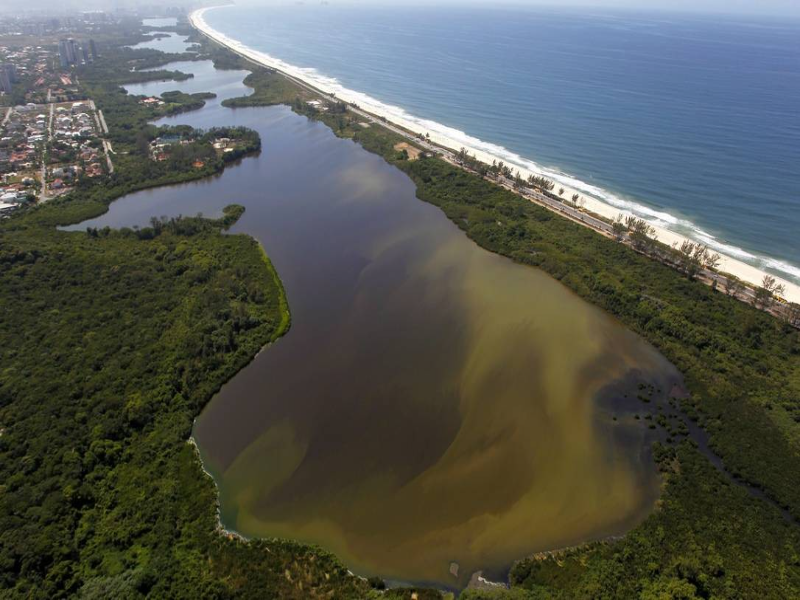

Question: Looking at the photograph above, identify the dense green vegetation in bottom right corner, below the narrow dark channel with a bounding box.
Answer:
[511,443,800,600]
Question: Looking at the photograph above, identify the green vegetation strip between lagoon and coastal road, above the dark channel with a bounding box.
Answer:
[382,152,800,508]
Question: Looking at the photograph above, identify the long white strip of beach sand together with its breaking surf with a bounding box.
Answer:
[189,5,800,303]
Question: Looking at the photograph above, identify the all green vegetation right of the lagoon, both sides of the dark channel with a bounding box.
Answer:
[203,37,800,599]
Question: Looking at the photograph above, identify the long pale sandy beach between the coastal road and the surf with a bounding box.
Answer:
[189,7,800,303]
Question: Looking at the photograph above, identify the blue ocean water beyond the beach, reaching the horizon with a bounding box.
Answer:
[205,4,800,282]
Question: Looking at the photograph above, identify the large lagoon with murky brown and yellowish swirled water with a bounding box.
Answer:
[70,54,678,587]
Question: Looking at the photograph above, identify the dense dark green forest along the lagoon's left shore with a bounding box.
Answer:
[0,24,372,599]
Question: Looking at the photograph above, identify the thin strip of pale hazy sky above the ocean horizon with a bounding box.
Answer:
[0,0,800,17]
